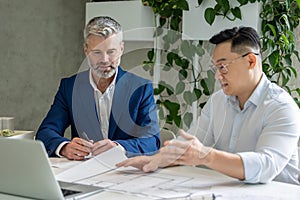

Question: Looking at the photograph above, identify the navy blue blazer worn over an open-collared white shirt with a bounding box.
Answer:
[36,67,160,157]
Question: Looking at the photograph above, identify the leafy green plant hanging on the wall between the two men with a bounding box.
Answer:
[142,0,214,127]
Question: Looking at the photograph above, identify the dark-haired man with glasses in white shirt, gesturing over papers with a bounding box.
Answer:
[118,27,300,184]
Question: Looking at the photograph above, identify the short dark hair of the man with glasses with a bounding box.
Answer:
[209,26,261,54]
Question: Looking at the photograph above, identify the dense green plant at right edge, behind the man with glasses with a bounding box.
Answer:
[260,0,300,107]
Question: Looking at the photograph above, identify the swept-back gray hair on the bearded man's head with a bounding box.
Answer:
[83,16,123,44]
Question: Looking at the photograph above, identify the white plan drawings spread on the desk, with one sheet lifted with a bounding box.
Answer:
[56,148,232,199]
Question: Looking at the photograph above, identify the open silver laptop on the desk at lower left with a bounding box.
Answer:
[0,138,103,200]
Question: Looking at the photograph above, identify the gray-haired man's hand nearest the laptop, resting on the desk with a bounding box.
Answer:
[60,137,93,160]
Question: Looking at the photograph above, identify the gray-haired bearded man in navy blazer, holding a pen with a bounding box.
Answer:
[36,16,160,160]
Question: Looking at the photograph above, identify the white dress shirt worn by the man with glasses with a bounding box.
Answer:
[197,74,300,184]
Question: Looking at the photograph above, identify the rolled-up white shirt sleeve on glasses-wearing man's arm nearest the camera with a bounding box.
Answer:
[238,99,300,183]
